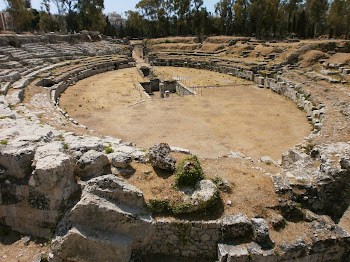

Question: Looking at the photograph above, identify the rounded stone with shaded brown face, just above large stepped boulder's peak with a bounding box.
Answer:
[77,150,109,178]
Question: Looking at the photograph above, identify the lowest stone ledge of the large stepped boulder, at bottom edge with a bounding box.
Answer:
[51,225,133,262]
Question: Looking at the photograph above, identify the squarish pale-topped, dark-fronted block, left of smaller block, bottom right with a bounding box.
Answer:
[222,213,253,241]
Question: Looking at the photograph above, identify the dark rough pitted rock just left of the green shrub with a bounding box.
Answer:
[148,143,176,171]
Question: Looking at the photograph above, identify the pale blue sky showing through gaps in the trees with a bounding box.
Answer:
[0,0,219,14]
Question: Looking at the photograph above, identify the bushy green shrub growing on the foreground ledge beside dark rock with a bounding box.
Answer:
[175,156,204,187]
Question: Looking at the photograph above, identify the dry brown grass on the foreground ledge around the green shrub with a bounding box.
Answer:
[119,154,278,219]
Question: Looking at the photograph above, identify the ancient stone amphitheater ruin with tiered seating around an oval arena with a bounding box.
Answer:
[0,34,350,262]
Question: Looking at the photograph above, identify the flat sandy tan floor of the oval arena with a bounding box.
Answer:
[60,67,311,160]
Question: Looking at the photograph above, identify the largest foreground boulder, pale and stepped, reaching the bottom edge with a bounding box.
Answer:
[51,175,155,262]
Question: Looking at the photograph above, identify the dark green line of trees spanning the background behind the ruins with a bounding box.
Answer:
[5,0,350,38]
